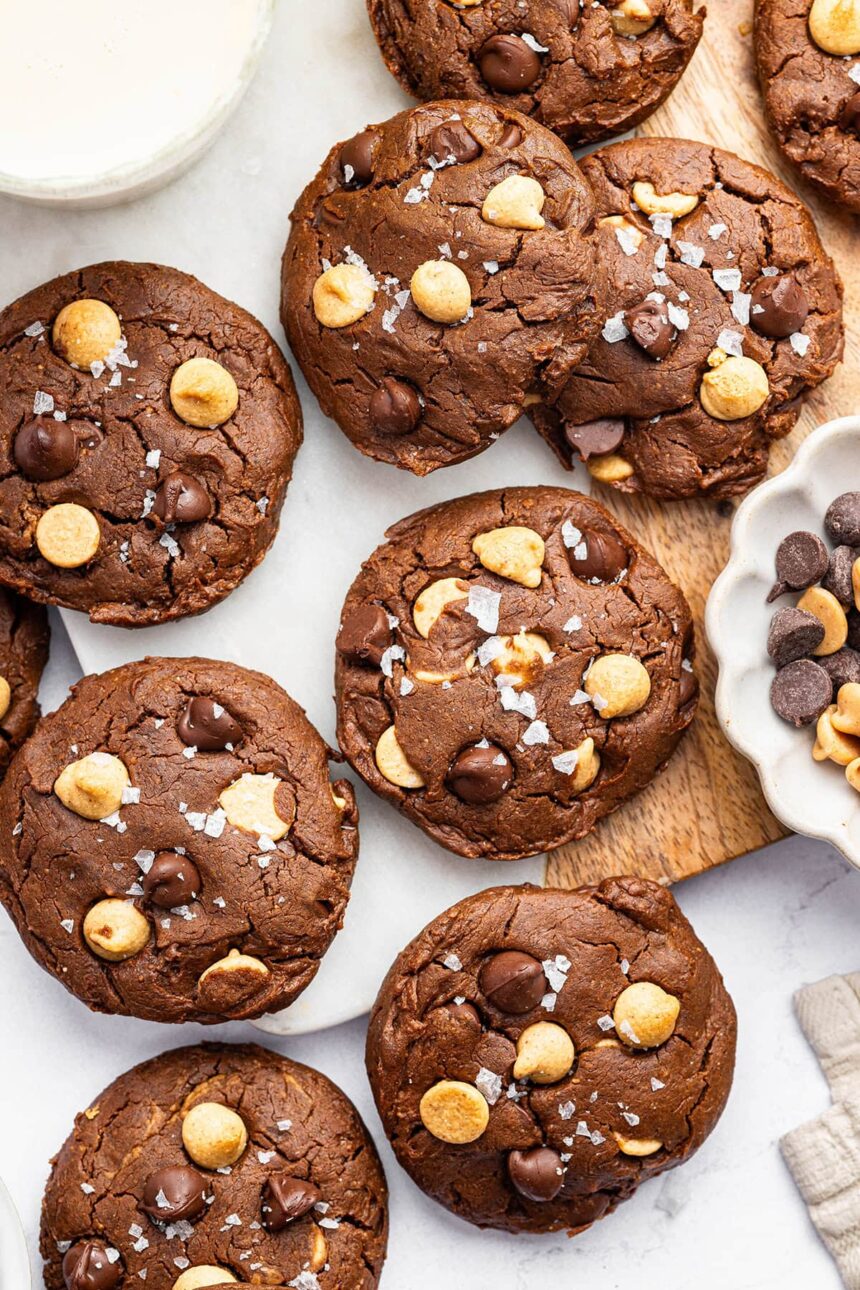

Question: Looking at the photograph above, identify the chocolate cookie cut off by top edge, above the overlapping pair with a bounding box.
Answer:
[367,0,704,146]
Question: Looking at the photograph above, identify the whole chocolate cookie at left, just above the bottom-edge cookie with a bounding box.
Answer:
[0,658,358,1023]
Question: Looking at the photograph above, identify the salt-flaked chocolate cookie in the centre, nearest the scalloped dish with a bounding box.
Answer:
[337,488,698,860]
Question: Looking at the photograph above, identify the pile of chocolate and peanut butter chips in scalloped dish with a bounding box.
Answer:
[767,493,860,792]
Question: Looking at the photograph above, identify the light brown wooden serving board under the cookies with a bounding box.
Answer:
[547,0,860,886]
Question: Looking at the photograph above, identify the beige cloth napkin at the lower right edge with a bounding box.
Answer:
[780,973,860,1290]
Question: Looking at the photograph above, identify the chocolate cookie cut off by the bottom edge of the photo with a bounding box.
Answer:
[41,1044,388,1290]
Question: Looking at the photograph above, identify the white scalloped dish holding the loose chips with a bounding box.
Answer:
[705,417,860,868]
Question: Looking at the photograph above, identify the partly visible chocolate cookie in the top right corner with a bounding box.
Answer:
[756,0,860,212]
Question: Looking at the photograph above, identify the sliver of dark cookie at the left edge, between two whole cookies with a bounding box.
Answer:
[0,588,49,779]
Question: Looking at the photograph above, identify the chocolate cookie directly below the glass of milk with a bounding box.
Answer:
[0,263,302,627]
